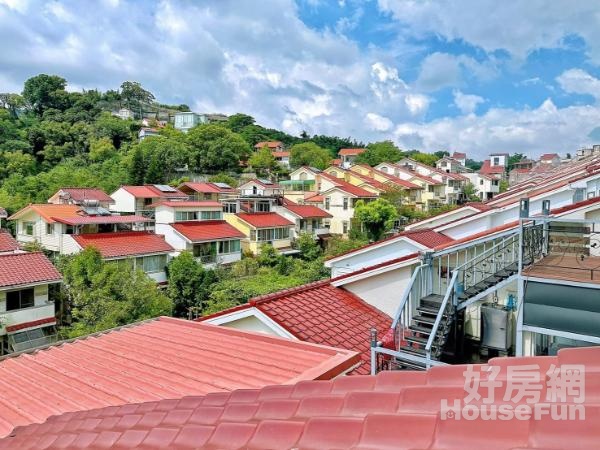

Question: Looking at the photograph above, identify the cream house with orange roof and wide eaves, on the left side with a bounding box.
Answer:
[9,203,151,255]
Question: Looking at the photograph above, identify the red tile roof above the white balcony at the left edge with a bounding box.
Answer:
[0,253,62,287]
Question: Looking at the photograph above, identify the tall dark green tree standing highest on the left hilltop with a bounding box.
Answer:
[23,74,67,117]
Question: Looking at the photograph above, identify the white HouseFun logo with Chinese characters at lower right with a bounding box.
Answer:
[441,364,585,420]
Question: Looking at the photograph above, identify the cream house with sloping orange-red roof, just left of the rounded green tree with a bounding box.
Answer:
[319,173,377,235]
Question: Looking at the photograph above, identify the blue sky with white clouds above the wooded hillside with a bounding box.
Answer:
[0,0,600,159]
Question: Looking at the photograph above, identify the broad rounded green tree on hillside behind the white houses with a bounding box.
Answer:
[187,124,251,172]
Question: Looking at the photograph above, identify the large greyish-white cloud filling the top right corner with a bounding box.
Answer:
[378,0,600,62]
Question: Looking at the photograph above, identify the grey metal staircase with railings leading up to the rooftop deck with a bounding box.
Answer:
[392,235,526,369]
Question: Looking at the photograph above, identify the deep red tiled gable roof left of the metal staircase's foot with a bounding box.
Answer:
[199,280,392,374]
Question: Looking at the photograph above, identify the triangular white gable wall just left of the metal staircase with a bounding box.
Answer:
[343,266,416,316]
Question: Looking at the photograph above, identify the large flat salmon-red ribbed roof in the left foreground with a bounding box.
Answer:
[0,317,359,438]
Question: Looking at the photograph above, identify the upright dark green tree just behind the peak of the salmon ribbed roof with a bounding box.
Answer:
[167,252,206,317]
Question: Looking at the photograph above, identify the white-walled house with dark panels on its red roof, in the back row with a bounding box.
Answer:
[110,184,188,219]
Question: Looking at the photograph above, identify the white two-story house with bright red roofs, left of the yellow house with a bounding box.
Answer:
[155,200,246,266]
